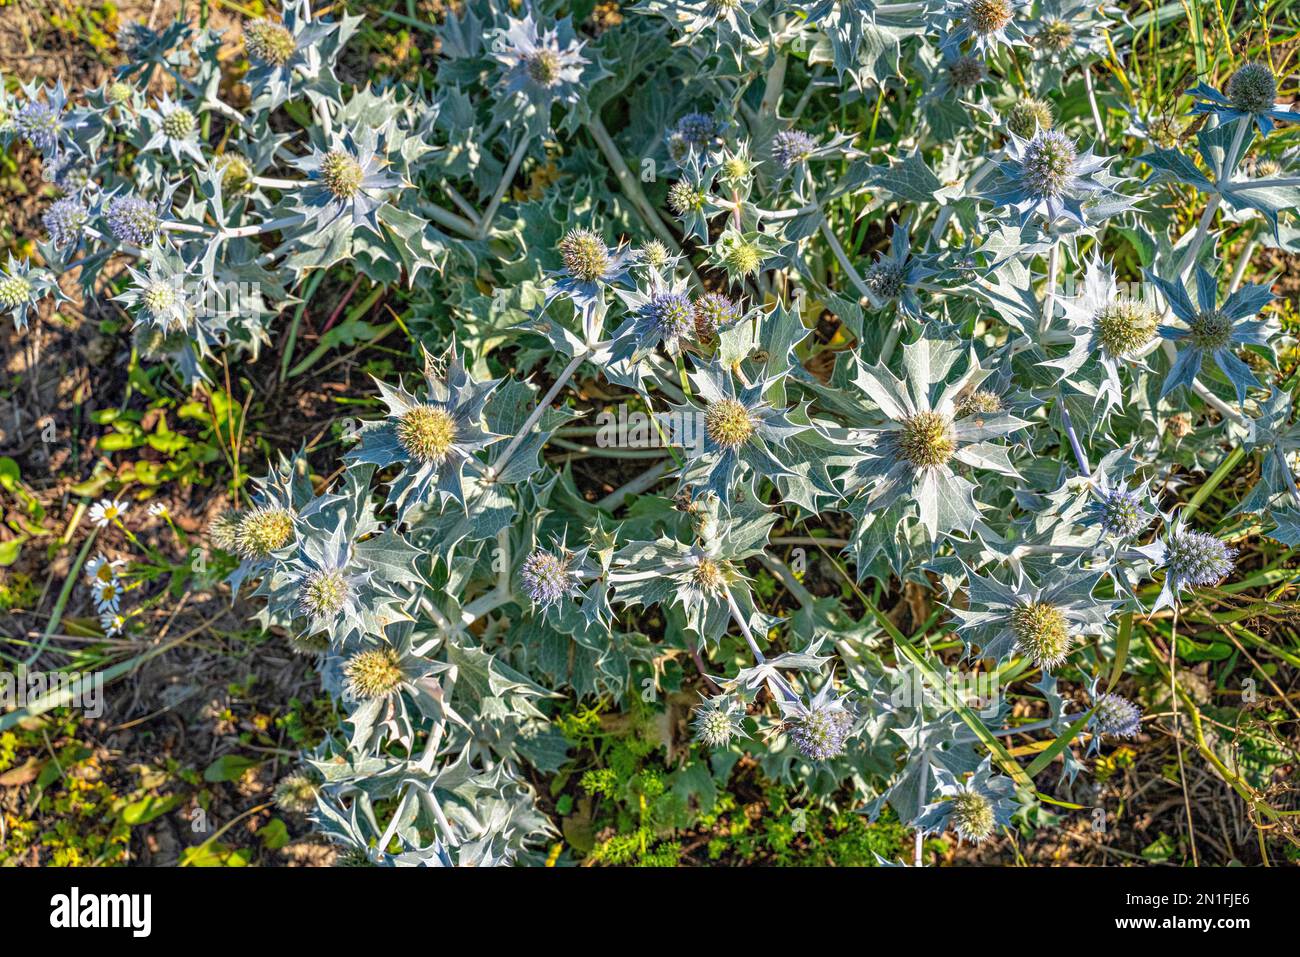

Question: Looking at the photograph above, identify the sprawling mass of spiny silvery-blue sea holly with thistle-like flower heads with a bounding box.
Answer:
[15,0,1300,866]
